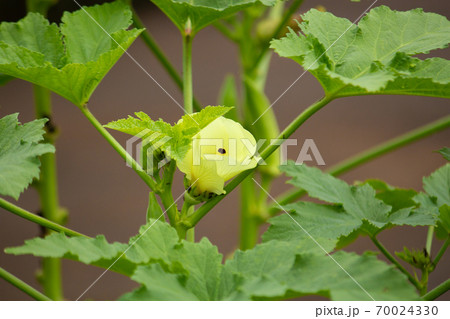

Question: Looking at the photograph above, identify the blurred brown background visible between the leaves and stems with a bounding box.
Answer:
[0,0,450,300]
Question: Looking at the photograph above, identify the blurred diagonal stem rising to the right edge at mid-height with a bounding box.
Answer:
[270,116,450,210]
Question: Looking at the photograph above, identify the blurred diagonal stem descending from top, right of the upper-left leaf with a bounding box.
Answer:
[133,10,202,111]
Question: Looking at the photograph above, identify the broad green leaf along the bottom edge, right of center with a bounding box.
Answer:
[224,244,418,300]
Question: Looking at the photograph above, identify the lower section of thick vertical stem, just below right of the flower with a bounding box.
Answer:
[240,174,259,250]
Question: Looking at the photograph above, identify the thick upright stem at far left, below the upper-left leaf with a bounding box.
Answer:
[33,85,67,300]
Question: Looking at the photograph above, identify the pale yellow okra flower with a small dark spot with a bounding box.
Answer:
[177,117,257,195]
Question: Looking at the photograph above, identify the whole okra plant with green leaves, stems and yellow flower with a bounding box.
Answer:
[0,0,450,300]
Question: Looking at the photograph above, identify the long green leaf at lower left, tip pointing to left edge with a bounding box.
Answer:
[5,220,178,276]
